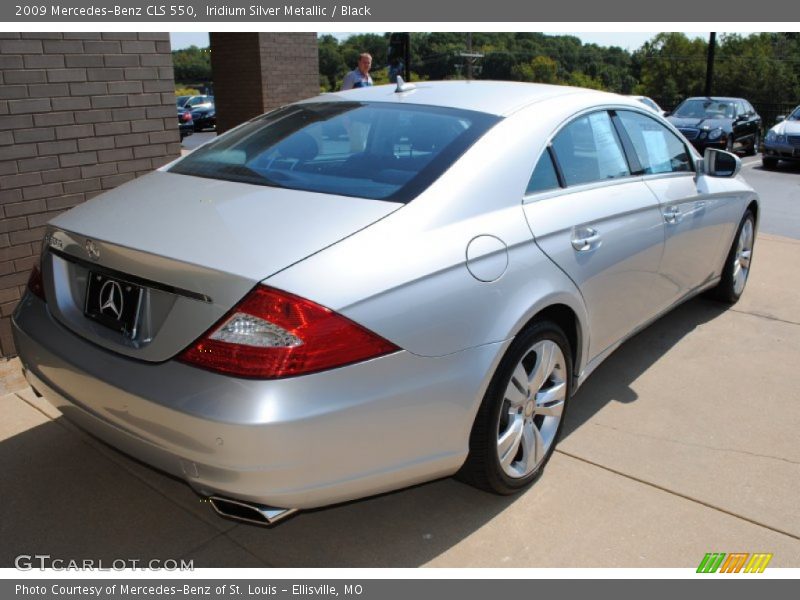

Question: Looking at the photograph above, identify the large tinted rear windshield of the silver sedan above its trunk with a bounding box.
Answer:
[170,102,499,202]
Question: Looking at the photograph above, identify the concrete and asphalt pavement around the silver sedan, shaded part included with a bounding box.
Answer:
[0,159,800,567]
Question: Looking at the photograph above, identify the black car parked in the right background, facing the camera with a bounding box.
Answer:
[669,97,761,156]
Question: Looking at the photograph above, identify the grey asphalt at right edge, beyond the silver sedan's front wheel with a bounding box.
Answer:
[742,155,800,239]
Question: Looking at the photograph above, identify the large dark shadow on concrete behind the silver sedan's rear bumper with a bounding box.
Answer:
[0,404,517,568]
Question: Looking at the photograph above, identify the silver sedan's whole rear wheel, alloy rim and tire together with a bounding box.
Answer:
[459,321,572,494]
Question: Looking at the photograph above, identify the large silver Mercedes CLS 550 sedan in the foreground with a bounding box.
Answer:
[13,81,759,523]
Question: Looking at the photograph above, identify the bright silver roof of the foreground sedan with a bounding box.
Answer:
[303,80,630,116]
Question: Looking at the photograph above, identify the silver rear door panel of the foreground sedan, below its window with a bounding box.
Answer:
[525,179,670,364]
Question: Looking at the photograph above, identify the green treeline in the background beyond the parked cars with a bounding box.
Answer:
[172,32,800,108]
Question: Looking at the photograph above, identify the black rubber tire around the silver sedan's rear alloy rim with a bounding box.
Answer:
[456,320,573,495]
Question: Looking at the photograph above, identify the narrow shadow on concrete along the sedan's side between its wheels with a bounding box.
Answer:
[562,296,728,438]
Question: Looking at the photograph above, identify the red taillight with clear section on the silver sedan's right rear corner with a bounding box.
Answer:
[179,285,400,379]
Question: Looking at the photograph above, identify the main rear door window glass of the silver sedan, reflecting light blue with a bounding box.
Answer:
[553,112,630,186]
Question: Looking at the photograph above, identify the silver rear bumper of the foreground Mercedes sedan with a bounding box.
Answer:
[12,294,506,508]
